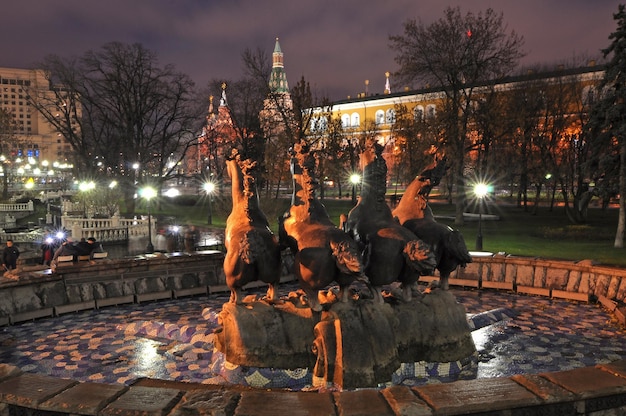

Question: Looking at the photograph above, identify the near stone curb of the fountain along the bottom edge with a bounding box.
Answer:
[0,360,626,416]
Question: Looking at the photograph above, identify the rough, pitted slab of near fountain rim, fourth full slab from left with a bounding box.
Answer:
[170,389,241,416]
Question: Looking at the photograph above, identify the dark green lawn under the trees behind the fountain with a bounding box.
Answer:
[90,192,626,266]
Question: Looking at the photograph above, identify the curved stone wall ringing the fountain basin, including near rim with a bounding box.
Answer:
[0,252,626,415]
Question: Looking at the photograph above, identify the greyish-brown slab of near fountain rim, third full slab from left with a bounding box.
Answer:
[99,386,183,416]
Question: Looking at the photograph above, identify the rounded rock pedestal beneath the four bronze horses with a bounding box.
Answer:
[216,290,476,388]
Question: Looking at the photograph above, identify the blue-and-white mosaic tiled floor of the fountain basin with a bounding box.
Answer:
[0,287,626,389]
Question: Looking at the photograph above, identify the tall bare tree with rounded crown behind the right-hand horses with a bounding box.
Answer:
[389,7,523,224]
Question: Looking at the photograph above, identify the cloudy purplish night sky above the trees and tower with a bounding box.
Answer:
[0,0,620,99]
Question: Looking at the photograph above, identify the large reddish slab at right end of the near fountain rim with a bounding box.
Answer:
[541,367,626,399]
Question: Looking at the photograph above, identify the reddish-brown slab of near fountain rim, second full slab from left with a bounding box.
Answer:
[39,383,127,415]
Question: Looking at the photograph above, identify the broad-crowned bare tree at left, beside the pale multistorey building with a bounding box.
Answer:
[29,42,202,213]
